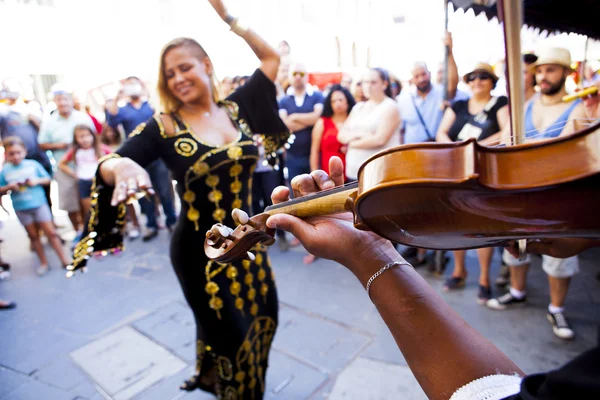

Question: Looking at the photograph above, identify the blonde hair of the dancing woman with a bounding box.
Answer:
[157,37,221,113]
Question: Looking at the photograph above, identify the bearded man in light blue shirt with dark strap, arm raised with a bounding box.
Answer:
[397,32,468,273]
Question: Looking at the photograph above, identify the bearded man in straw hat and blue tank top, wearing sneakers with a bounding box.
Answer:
[486,48,581,340]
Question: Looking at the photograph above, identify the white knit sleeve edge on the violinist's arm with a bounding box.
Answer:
[450,375,522,400]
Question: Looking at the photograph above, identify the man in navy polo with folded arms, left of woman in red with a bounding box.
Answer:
[279,63,323,181]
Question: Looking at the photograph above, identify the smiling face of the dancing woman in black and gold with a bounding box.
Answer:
[162,45,212,104]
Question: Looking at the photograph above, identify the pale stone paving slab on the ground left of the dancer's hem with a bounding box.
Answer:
[71,327,186,400]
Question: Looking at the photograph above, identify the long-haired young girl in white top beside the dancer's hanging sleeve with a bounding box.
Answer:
[58,125,111,219]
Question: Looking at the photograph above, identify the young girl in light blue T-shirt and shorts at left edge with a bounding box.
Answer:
[0,136,69,276]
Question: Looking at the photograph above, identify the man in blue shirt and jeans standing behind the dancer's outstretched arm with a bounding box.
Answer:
[106,76,177,241]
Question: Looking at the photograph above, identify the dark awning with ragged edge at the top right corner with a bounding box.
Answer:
[449,0,600,40]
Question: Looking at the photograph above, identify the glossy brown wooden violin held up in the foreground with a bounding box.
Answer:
[204,122,600,263]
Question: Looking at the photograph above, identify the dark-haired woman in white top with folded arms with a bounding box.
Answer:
[338,68,402,181]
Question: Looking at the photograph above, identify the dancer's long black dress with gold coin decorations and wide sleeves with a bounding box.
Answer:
[74,69,289,400]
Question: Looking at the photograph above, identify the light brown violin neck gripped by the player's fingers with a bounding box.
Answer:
[264,182,358,218]
